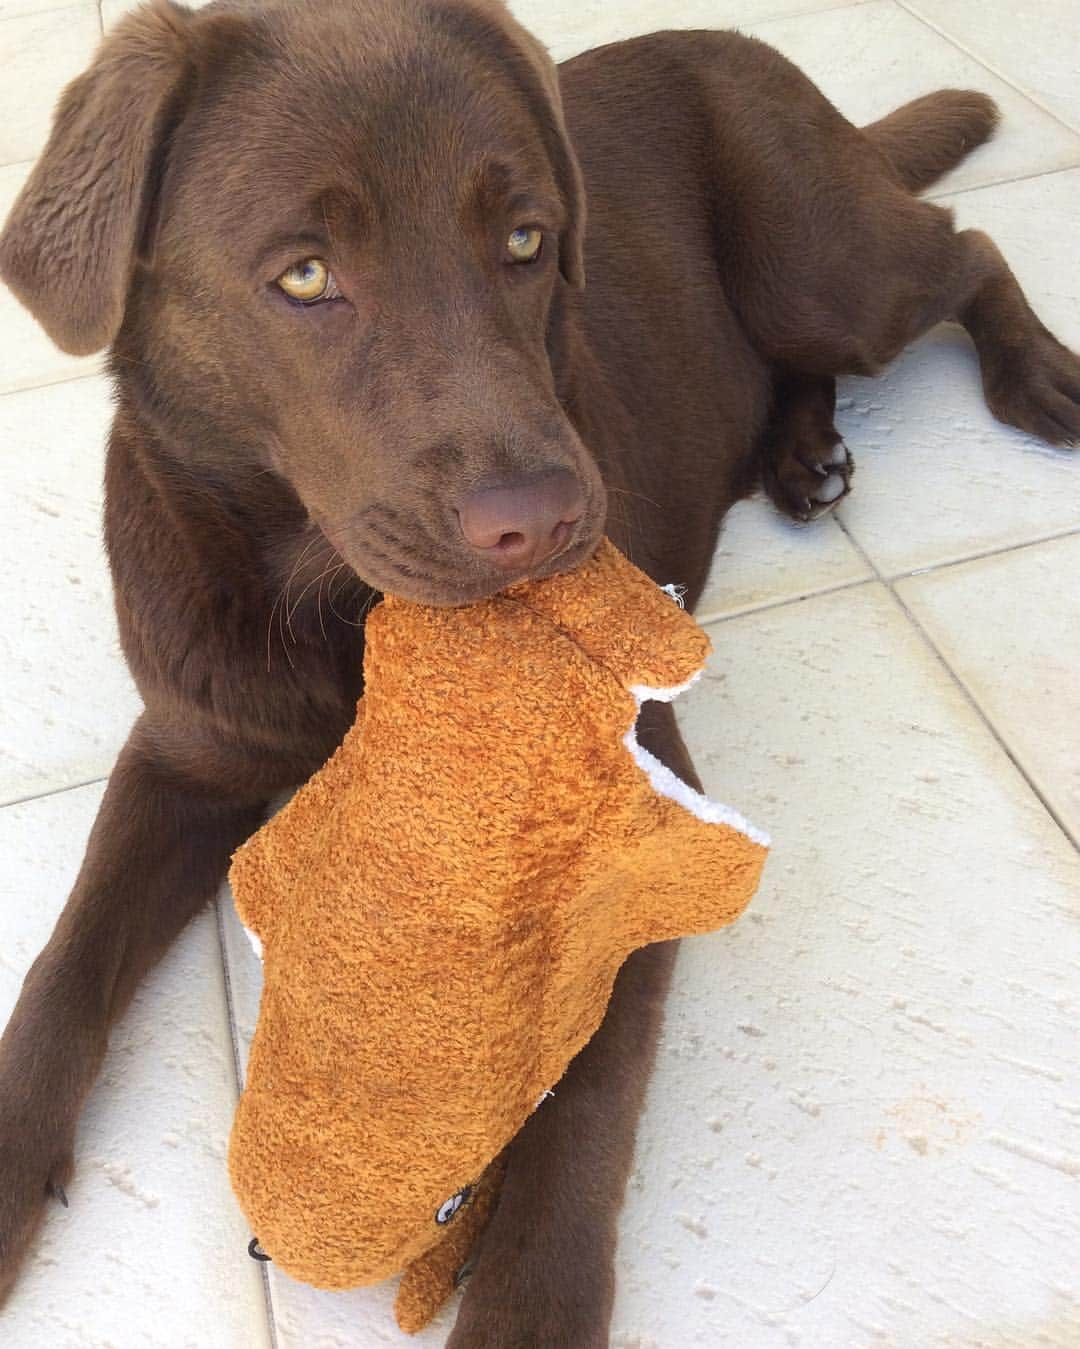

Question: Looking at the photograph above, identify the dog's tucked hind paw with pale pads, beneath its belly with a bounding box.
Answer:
[759,372,855,521]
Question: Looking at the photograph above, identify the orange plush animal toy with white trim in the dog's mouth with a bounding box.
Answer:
[229,542,767,1330]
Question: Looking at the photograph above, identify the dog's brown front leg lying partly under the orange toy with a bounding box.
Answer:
[448,703,700,1349]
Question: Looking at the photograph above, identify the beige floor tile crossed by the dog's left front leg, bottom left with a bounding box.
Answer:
[0,786,271,1349]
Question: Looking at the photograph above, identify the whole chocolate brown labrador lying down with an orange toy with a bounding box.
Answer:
[0,0,1080,1349]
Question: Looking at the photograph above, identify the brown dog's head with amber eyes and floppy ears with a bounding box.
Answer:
[0,0,605,603]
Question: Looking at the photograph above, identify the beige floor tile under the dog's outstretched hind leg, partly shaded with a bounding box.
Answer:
[837,170,1080,575]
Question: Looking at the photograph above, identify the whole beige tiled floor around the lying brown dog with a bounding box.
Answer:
[0,0,1080,1349]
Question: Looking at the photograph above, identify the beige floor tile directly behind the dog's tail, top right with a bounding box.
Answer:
[750,0,1080,192]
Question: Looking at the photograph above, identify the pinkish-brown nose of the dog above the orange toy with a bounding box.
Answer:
[458,468,585,571]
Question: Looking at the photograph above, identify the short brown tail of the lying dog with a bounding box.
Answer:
[863,89,1000,192]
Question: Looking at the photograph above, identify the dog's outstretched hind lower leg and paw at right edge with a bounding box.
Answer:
[948,229,1080,445]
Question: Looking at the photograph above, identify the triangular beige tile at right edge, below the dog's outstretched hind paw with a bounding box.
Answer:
[897,534,1080,842]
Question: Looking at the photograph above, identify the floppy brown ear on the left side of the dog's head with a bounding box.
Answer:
[0,0,193,356]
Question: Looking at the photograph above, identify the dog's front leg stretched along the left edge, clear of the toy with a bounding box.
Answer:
[0,716,264,1303]
